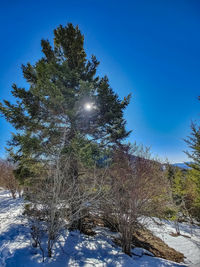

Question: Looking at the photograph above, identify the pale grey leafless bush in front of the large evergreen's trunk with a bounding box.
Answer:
[26,154,105,257]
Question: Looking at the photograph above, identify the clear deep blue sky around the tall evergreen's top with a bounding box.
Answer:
[0,0,200,162]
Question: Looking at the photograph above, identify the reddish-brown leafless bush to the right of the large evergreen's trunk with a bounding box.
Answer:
[103,146,168,255]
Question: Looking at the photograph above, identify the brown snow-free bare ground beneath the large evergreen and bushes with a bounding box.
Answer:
[81,215,184,263]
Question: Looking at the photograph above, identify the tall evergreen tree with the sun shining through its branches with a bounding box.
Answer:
[0,24,130,183]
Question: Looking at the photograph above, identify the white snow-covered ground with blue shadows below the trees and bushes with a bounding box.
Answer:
[0,190,200,267]
